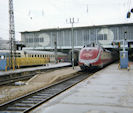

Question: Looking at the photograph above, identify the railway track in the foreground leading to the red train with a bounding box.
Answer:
[0,73,92,113]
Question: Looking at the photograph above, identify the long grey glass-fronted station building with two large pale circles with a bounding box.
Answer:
[21,23,133,50]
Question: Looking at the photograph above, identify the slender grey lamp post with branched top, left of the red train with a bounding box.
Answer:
[66,18,79,69]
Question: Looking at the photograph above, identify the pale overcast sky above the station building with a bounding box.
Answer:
[0,0,133,40]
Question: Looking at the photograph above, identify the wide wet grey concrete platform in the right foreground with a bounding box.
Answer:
[30,64,133,113]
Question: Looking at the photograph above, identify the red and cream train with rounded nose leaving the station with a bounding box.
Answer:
[79,44,118,70]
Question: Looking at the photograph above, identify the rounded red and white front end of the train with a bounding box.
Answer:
[79,47,101,70]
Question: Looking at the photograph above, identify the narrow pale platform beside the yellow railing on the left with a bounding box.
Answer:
[0,62,71,76]
